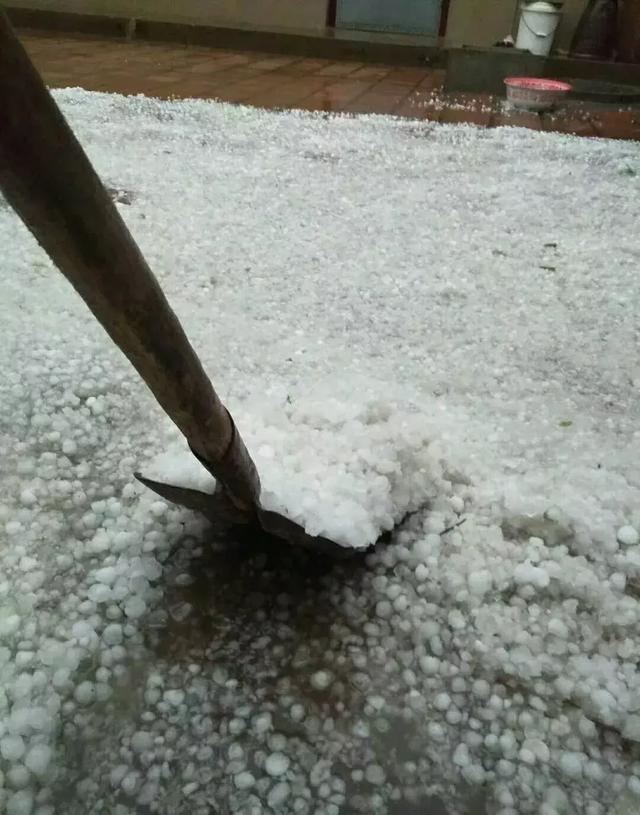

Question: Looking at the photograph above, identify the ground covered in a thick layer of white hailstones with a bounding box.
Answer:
[0,90,640,815]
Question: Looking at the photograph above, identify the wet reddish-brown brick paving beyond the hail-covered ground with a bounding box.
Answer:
[21,32,640,139]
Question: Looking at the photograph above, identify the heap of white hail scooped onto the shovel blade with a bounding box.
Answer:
[150,393,450,549]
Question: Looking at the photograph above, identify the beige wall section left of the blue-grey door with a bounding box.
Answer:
[8,0,328,30]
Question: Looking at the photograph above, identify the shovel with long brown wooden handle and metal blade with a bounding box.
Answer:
[0,9,352,556]
